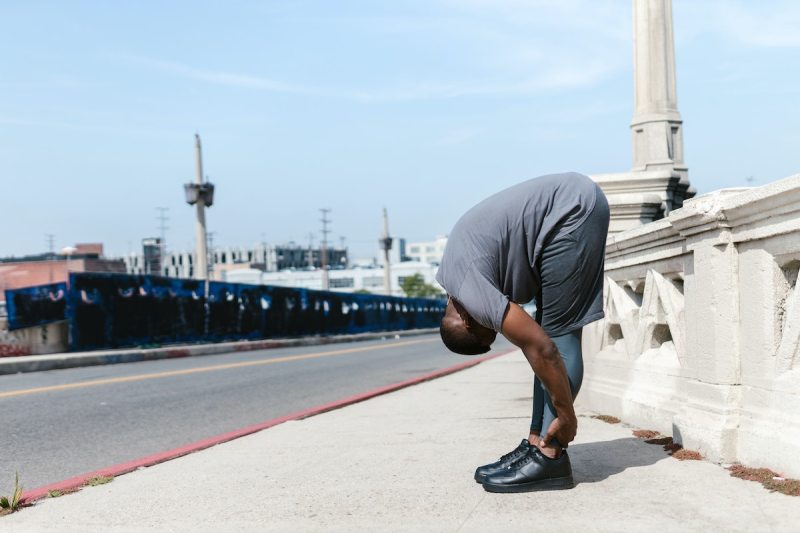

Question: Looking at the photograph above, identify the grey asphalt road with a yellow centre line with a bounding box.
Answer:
[0,335,510,494]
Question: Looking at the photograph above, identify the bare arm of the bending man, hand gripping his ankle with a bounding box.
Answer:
[502,302,578,447]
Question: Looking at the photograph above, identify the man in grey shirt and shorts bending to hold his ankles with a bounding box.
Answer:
[436,173,609,492]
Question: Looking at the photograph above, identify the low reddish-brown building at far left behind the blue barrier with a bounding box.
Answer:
[0,243,126,301]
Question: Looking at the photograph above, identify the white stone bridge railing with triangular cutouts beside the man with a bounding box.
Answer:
[579,175,800,477]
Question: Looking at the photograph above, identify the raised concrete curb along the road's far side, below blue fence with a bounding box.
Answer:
[0,328,438,375]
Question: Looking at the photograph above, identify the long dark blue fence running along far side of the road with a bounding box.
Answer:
[7,273,446,351]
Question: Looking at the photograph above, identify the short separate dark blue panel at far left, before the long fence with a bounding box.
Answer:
[5,283,67,330]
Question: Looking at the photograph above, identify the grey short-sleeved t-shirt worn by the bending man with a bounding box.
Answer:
[436,172,597,332]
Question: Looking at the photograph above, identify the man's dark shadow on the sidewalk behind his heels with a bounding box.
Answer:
[569,437,669,483]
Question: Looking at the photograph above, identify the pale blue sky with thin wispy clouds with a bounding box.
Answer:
[0,0,800,256]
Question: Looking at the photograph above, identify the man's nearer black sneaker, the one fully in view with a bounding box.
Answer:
[483,446,575,492]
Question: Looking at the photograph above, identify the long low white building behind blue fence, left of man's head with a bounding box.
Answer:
[222,261,444,296]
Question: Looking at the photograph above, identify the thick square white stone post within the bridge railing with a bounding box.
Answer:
[669,198,742,462]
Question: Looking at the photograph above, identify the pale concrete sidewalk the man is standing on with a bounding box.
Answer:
[0,352,800,533]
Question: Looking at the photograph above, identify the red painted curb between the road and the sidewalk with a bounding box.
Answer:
[21,348,516,504]
